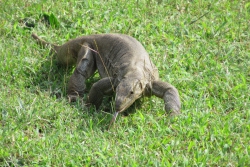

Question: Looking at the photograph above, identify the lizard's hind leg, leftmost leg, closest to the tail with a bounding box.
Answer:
[67,43,96,101]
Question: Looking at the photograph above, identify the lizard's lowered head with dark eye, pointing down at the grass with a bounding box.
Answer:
[115,79,145,112]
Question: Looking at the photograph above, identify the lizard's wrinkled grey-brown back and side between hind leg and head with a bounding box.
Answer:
[77,34,158,80]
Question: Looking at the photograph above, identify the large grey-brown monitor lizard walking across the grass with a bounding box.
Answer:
[32,33,181,128]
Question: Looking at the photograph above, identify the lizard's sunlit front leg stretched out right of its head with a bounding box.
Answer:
[147,81,181,115]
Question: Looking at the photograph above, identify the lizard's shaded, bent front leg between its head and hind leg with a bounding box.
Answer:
[87,77,115,109]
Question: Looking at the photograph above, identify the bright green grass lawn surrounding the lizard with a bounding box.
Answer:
[0,0,250,166]
